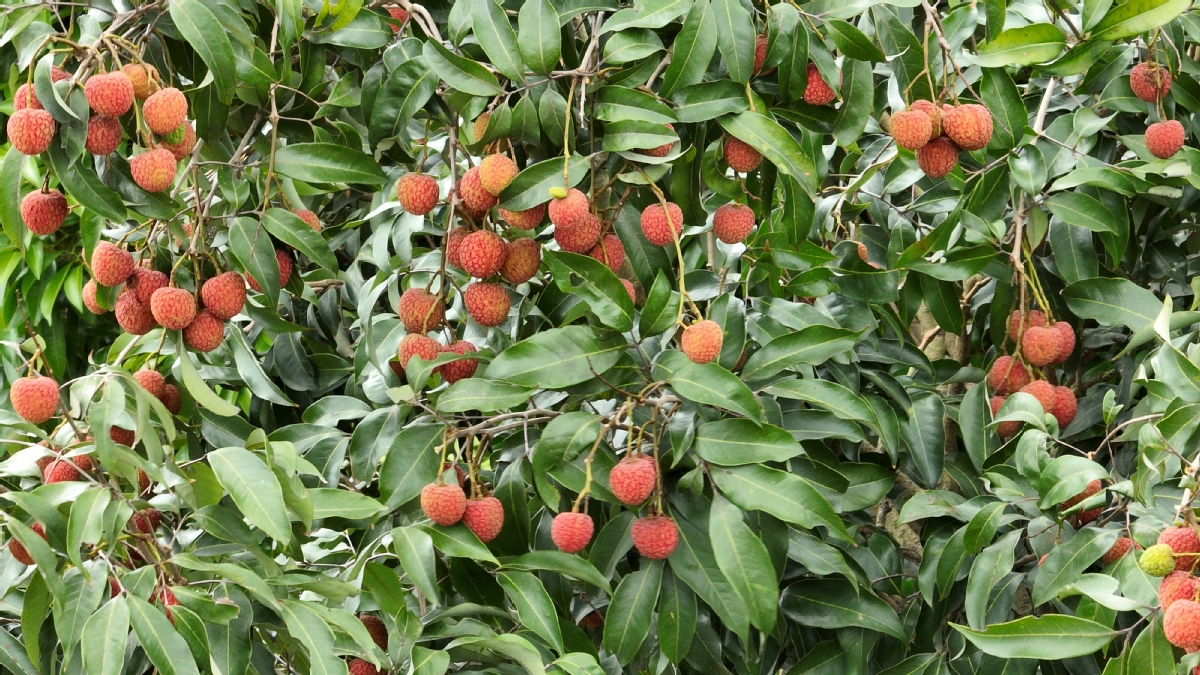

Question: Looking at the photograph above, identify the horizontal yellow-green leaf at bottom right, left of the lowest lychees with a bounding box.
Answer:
[950,614,1117,661]
